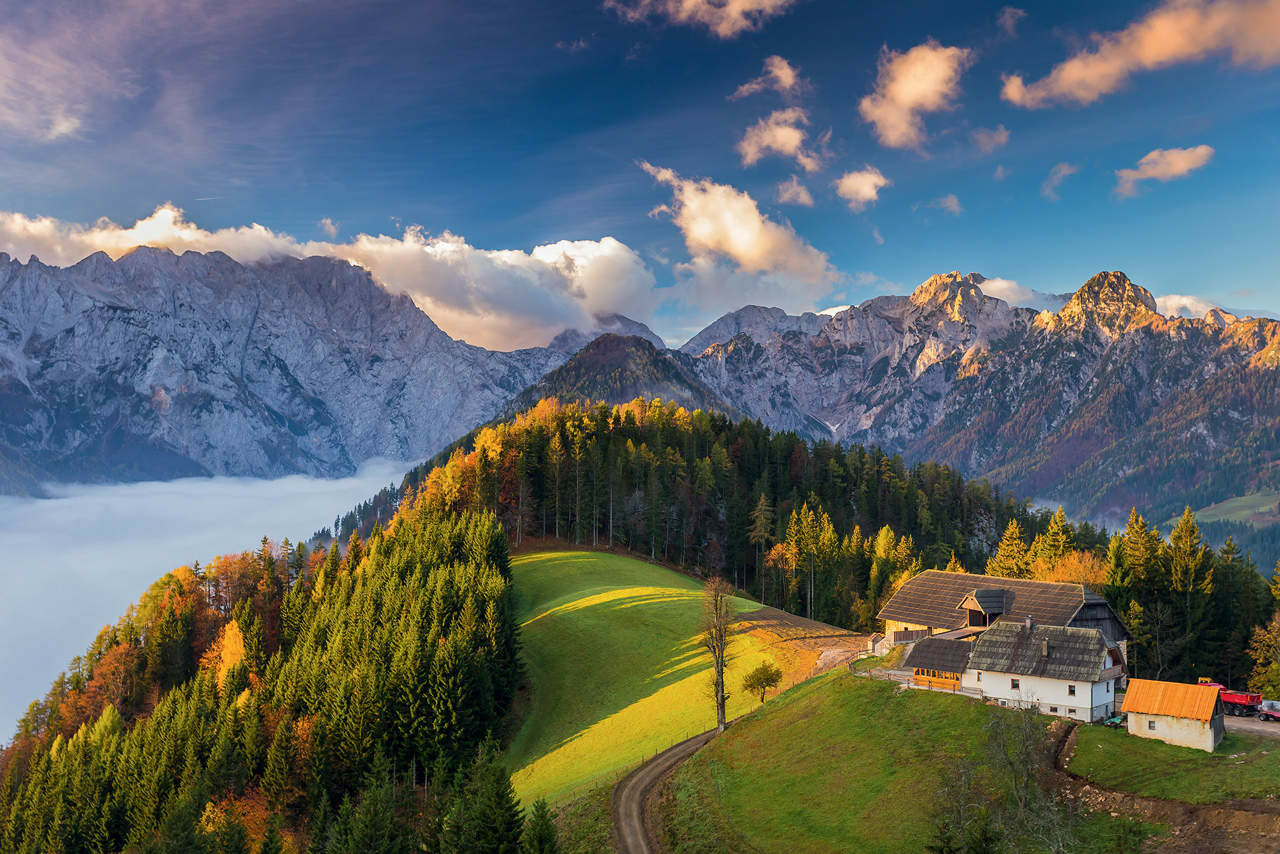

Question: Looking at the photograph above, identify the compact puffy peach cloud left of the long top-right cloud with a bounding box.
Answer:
[858,38,974,149]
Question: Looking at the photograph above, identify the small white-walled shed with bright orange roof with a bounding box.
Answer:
[1124,679,1225,753]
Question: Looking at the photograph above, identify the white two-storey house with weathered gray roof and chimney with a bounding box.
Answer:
[960,618,1124,722]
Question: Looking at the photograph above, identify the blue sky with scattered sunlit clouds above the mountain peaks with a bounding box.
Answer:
[0,0,1280,348]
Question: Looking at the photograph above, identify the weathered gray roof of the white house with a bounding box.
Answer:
[969,620,1107,682]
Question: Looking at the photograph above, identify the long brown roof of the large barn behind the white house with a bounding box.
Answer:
[877,570,1090,629]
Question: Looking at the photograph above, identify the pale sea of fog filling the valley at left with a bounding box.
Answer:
[0,461,410,744]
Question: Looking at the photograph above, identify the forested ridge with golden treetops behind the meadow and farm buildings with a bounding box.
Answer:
[399,401,1275,684]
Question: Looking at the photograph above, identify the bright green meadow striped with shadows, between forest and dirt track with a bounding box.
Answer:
[508,552,788,803]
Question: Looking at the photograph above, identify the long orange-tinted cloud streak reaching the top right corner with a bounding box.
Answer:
[1001,0,1280,109]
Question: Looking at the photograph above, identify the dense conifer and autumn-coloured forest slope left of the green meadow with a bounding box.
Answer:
[0,502,545,853]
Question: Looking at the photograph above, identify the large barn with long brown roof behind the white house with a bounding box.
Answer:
[877,570,1129,652]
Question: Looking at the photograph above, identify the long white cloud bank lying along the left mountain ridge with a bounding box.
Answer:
[0,205,657,350]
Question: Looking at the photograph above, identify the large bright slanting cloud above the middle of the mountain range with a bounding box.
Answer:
[641,163,837,287]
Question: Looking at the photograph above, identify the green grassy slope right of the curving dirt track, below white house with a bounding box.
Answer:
[664,671,1146,854]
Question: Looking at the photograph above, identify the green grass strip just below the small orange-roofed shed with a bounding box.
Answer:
[1071,726,1280,804]
